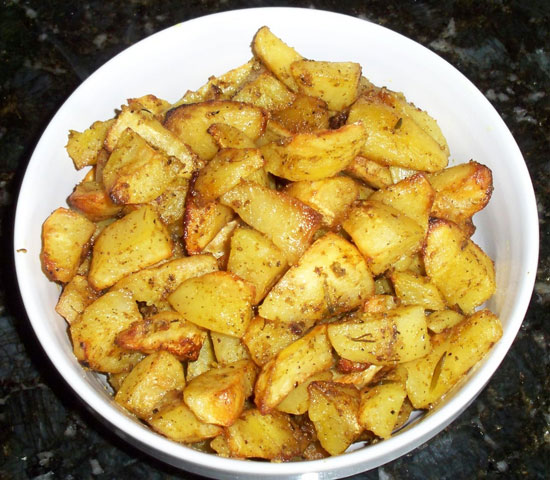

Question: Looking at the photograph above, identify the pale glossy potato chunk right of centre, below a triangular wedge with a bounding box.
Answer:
[342,200,424,275]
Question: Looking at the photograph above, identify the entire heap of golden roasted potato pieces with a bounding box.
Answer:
[41,27,502,462]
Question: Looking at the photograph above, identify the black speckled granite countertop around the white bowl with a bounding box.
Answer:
[0,0,550,480]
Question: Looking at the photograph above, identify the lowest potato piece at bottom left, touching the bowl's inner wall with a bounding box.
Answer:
[147,401,223,443]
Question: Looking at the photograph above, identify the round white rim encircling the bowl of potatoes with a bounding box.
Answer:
[14,7,539,478]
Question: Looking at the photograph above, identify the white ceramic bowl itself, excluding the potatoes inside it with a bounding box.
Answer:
[14,8,538,479]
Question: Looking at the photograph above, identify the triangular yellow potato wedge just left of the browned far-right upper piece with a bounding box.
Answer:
[369,173,435,232]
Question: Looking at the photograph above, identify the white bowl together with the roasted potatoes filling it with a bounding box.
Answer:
[14,8,538,478]
